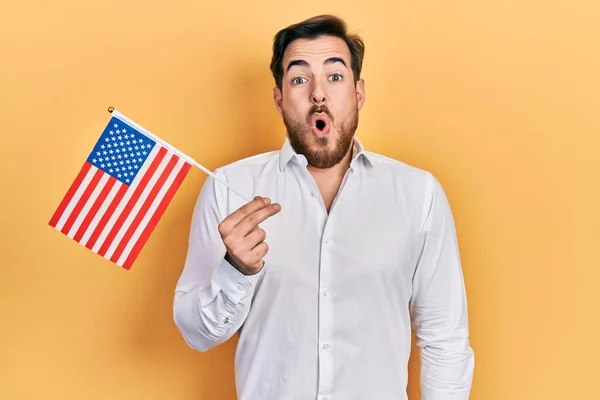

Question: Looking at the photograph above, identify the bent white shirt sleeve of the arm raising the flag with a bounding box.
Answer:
[173,171,262,351]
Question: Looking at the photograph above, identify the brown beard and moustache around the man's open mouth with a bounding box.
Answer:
[282,106,358,169]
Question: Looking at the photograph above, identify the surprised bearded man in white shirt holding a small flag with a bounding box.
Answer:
[174,16,474,400]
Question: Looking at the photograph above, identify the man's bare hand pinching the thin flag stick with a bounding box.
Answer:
[219,196,281,275]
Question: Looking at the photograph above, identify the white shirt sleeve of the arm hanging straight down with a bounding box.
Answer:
[410,175,474,400]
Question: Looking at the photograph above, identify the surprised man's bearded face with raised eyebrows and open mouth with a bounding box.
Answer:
[274,36,365,168]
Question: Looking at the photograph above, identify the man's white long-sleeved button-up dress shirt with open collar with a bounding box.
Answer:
[174,139,474,400]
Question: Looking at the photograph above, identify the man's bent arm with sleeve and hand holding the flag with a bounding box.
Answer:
[173,172,274,351]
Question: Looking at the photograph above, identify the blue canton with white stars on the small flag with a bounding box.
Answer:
[87,117,156,185]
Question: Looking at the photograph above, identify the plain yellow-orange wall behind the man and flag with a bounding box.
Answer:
[0,0,600,400]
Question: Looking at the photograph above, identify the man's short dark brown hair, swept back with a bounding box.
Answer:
[271,15,365,90]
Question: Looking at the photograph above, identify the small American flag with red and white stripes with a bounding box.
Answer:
[49,110,191,270]
